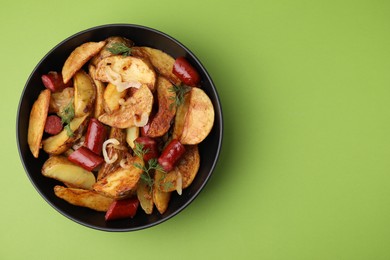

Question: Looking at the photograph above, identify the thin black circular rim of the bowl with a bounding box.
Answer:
[16,23,224,232]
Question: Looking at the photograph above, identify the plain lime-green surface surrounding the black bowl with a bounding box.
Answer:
[0,0,390,260]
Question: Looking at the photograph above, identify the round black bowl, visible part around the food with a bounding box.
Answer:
[16,24,223,231]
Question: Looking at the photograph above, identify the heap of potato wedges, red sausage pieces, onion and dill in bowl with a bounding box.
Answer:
[27,36,215,221]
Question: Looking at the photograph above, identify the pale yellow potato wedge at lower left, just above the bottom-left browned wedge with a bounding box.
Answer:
[42,156,96,190]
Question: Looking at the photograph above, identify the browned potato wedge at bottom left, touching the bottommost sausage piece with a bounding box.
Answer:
[54,185,114,212]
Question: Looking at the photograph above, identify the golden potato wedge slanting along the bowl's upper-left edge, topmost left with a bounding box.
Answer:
[62,41,106,84]
